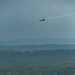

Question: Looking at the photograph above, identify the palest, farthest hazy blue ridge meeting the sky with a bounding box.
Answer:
[0,38,75,46]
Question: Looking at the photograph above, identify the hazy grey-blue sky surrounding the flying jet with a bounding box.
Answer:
[0,0,75,41]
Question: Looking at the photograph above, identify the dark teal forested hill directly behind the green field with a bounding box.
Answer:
[0,50,75,64]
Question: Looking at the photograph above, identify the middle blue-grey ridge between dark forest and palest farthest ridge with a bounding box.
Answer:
[0,44,75,51]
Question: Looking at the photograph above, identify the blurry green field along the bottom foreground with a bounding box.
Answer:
[0,63,75,75]
